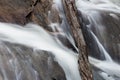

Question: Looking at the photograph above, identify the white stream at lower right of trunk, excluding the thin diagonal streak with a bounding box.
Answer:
[89,57,120,80]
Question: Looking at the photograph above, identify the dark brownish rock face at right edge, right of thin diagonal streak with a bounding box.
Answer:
[101,14,120,62]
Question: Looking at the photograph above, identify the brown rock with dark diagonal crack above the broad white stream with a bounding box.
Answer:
[0,0,60,31]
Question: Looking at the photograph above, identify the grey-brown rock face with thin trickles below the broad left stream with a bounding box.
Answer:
[0,42,66,80]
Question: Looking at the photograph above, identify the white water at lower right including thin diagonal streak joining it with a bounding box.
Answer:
[89,32,120,80]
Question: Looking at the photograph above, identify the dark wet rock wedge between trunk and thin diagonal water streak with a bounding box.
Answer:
[83,22,105,60]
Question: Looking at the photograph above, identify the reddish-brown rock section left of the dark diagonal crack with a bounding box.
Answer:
[0,0,31,24]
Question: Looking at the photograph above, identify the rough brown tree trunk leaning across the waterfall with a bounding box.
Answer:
[62,0,93,80]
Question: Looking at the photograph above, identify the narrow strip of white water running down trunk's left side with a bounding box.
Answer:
[53,0,78,51]
